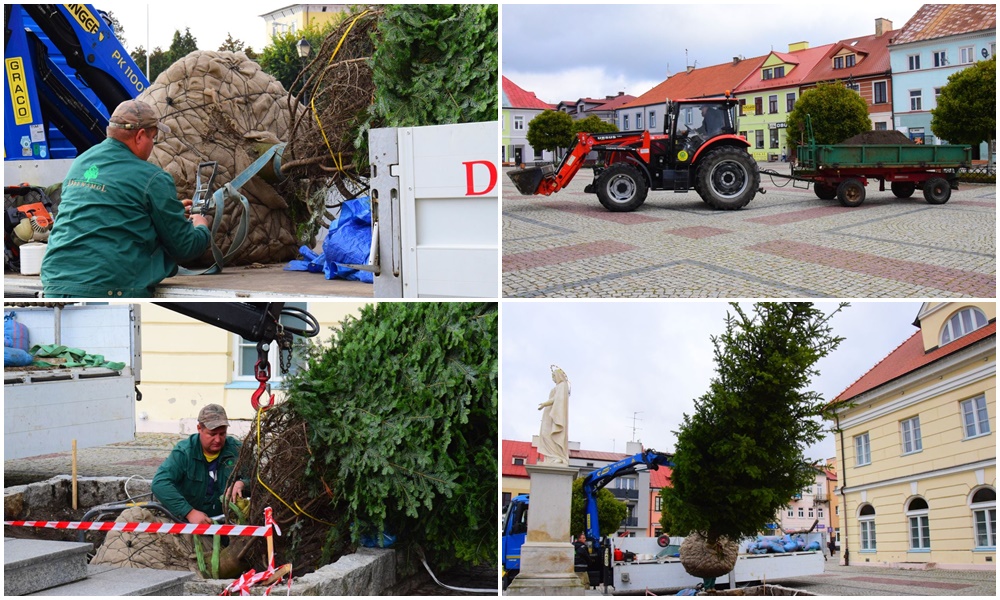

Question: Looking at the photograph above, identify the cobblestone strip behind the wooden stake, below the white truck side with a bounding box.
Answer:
[3,433,187,487]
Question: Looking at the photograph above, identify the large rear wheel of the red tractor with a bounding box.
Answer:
[695,146,760,210]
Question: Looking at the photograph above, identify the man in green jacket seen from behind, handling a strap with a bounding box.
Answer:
[41,100,211,298]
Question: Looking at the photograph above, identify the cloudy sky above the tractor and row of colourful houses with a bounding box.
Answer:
[501,0,923,104]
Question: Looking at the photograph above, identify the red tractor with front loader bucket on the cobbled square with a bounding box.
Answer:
[507,95,760,212]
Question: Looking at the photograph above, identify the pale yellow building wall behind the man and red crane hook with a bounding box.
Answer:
[136,302,365,435]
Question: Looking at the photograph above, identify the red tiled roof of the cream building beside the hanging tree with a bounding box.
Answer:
[834,321,997,403]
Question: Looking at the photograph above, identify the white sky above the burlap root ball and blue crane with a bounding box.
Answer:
[93,0,276,52]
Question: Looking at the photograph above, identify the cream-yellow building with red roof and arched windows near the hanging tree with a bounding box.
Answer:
[833,302,996,569]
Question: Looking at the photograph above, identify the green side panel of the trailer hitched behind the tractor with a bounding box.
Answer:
[798,144,972,170]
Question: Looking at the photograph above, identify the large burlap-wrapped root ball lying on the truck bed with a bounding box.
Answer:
[140,51,304,264]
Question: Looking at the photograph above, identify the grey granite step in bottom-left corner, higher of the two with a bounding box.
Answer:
[3,538,94,596]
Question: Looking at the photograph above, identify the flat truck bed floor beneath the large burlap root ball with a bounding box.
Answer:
[3,264,374,298]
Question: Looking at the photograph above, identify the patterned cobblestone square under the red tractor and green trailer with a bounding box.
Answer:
[502,163,996,298]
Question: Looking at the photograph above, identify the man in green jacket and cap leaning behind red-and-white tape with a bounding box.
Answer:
[152,404,245,524]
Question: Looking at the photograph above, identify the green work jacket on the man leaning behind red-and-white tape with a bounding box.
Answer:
[153,433,243,519]
